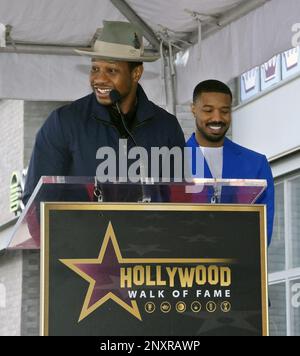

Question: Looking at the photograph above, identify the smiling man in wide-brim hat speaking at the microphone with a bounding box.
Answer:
[24,21,185,202]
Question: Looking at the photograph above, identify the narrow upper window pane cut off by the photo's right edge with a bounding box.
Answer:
[288,177,300,268]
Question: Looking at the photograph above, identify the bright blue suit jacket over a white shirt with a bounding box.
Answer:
[187,134,274,244]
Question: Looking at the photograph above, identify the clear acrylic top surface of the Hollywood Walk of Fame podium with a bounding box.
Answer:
[6,176,267,249]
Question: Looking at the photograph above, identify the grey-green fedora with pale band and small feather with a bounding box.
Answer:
[75,21,160,62]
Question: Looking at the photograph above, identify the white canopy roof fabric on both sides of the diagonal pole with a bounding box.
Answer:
[0,0,244,45]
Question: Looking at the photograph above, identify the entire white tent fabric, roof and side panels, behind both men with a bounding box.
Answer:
[0,0,300,104]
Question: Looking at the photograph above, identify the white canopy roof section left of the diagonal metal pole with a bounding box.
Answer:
[0,0,125,45]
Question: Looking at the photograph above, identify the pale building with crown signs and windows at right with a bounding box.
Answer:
[232,47,300,335]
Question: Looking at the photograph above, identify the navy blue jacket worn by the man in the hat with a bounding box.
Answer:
[23,85,185,202]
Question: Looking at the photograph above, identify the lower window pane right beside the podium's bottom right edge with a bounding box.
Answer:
[269,283,287,336]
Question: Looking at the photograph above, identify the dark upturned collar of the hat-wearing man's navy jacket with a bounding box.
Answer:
[91,84,155,126]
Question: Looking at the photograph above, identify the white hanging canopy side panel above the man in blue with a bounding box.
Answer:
[177,0,300,103]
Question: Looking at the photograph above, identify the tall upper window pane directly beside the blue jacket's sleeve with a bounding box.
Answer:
[268,183,285,273]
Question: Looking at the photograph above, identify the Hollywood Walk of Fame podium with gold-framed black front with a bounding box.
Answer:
[8,177,268,336]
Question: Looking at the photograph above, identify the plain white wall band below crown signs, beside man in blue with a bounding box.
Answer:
[232,77,300,158]
